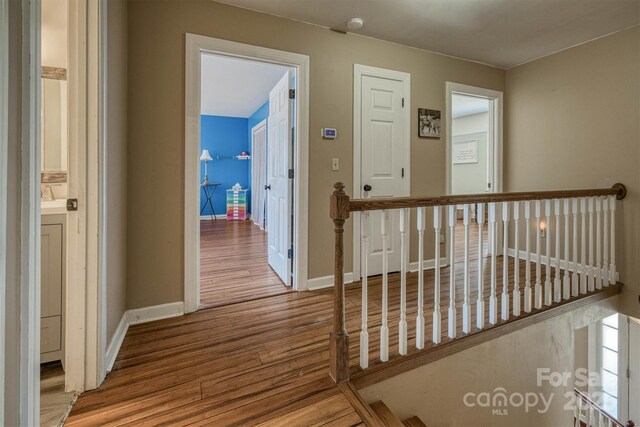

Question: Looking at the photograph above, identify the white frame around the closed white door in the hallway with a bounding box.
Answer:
[347,64,411,280]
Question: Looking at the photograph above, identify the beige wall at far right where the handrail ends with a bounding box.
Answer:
[504,27,640,317]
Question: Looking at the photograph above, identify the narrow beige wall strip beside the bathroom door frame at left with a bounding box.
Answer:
[106,0,127,343]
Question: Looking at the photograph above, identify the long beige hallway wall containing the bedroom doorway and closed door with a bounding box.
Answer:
[127,0,505,308]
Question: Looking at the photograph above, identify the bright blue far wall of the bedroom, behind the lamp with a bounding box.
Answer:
[200,115,251,215]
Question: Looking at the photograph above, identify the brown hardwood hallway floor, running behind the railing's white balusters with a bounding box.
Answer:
[67,221,608,426]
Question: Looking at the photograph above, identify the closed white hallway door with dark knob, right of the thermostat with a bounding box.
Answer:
[353,65,410,277]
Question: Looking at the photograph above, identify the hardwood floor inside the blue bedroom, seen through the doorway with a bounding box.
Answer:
[200,220,291,308]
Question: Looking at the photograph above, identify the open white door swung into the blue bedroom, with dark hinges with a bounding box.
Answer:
[267,71,292,285]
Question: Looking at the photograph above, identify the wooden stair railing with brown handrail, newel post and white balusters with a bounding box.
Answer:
[330,182,626,382]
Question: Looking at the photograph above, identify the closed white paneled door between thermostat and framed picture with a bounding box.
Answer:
[354,69,409,275]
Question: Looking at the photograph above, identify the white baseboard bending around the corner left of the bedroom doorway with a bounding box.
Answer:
[106,301,184,372]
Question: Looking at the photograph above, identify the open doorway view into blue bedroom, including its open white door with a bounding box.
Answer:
[199,53,296,307]
